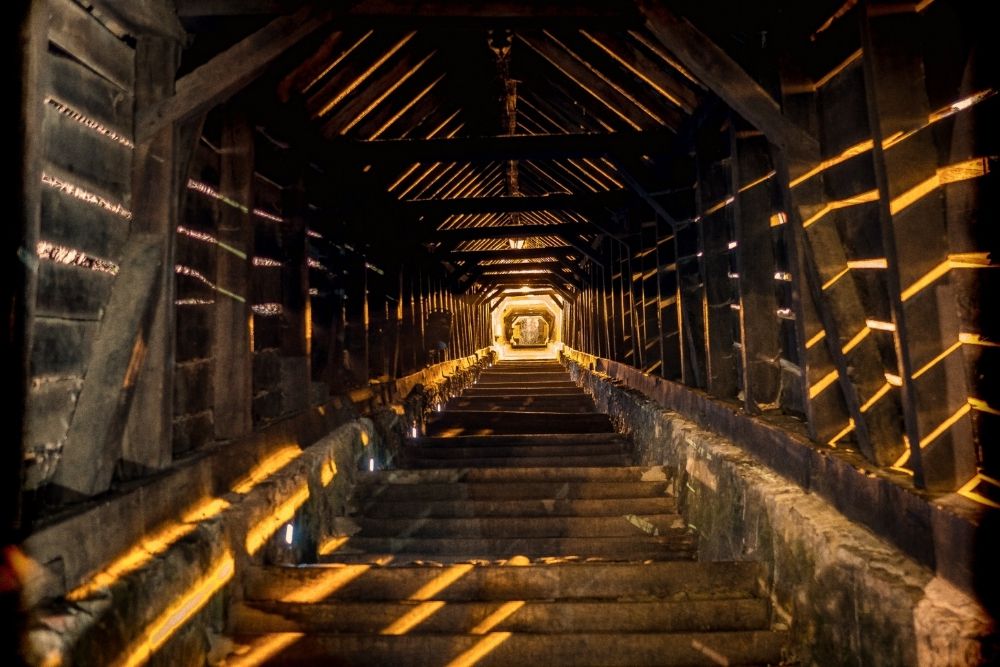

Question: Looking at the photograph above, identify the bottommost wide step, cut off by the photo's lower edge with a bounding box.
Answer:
[227,630,787,667]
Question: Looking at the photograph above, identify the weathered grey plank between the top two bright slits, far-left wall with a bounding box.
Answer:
[42,105,132,196]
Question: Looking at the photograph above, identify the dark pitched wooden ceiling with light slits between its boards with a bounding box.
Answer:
[177,0,840,298]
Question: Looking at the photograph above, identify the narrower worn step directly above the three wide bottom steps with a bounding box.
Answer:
[320,530,696,563]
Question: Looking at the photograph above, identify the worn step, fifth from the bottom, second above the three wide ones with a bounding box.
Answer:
[353,514,688,539]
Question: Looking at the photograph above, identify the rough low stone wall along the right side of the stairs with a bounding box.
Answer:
[563,351,995,667]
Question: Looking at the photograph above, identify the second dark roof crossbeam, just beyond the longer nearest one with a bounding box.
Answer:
[403,190,630,218]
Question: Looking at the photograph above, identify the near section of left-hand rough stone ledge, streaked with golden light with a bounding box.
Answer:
[25,419,377,664]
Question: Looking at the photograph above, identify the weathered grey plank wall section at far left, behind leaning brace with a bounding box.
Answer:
[25,0,135,490]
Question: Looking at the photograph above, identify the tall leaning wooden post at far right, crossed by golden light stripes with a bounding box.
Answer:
[862,2,976,491]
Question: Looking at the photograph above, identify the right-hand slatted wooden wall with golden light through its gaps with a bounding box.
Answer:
[567,0,1000,503]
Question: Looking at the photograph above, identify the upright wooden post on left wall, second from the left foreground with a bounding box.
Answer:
[212,103,254,439]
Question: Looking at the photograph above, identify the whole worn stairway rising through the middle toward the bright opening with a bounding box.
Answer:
[230,362,786,666]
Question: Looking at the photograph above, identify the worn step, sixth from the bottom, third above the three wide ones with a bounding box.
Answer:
[355,482,667,503]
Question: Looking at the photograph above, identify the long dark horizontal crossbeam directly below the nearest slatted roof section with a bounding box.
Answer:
[348,129,674,163]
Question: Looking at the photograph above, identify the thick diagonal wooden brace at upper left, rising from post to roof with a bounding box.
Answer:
[135,4,335,144]
